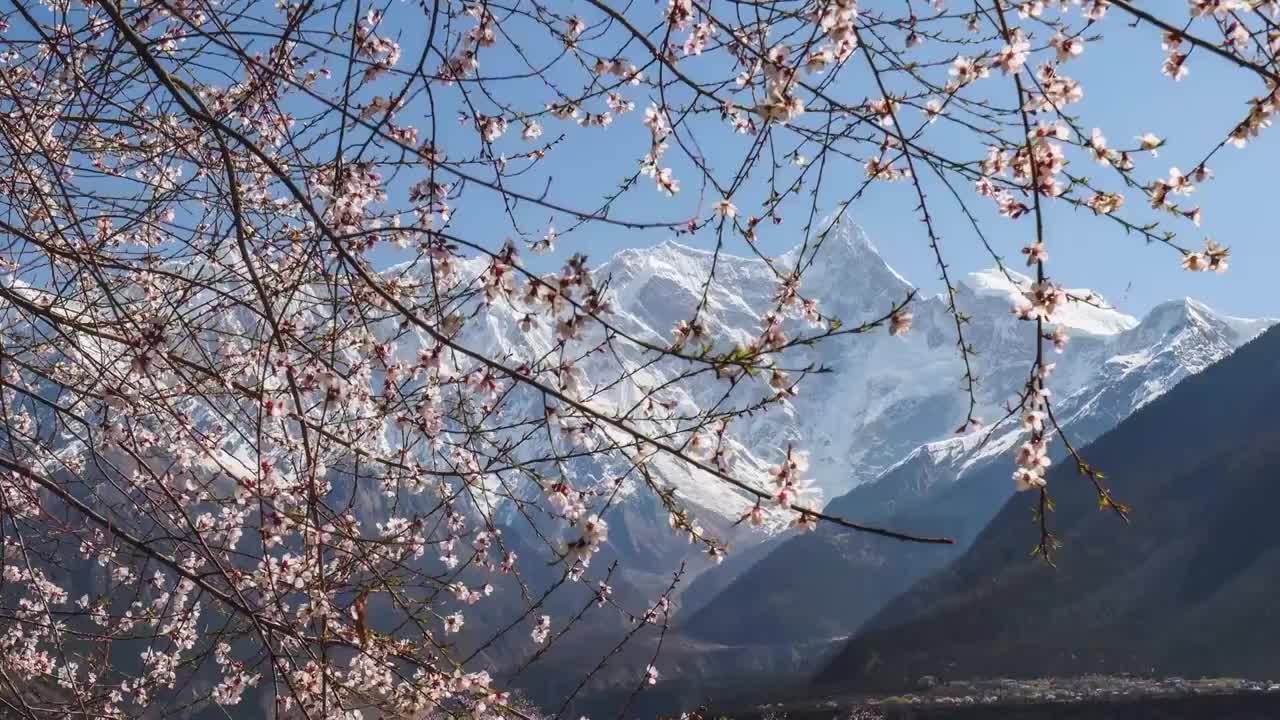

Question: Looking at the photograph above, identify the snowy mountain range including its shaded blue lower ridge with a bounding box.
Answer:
[486,215,1272,697]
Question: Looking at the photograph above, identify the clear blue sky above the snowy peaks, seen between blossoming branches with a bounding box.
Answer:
[363,0,1280,316]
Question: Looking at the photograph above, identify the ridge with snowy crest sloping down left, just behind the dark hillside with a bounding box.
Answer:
[685,254,1272,646]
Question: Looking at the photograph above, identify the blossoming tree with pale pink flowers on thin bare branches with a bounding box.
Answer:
[0,0,1280,719]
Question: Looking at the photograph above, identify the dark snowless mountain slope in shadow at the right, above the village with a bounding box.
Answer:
[818,331,1280,689]
